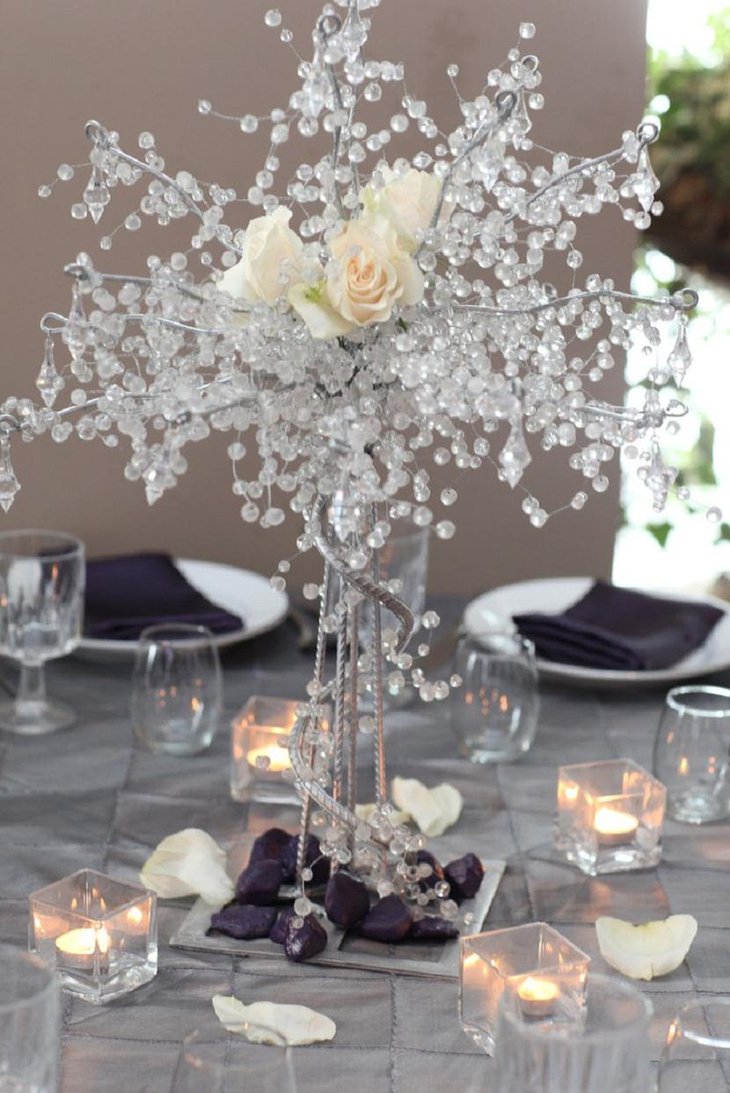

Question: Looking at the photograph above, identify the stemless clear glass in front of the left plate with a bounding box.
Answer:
[131,623,223,755]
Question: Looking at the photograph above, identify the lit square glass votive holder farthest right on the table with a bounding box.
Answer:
[555,759,667,877]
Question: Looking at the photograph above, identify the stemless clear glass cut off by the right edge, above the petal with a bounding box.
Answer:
[654,686,730,823]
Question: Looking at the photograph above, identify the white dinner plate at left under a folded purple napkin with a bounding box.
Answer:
[75,557,289,660]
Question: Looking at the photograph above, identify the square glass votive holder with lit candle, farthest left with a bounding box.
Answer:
[28,869,157,1006]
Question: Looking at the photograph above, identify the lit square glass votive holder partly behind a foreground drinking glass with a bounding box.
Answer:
[459,922,590,1055]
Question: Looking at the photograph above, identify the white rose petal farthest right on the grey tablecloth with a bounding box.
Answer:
[596,915,697,979]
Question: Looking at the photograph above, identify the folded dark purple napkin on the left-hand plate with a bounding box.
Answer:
[84,553,244,642]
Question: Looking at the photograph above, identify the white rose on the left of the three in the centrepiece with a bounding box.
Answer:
[217,205,304,304]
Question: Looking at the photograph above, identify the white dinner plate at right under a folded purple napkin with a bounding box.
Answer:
[463,577,730,686]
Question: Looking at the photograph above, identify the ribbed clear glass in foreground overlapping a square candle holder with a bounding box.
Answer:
[494,975,651,1093]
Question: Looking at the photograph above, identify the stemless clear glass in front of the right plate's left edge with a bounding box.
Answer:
[451,633,540,763]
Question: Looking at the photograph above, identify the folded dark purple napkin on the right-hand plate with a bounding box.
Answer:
[514,580,725,671]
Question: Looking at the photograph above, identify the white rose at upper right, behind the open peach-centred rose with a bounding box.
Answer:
[363,164,441,251]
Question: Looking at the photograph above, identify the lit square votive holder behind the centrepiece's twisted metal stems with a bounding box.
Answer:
[231,694,302,804]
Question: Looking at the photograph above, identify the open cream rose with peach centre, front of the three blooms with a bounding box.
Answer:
[325,216,423,327]
